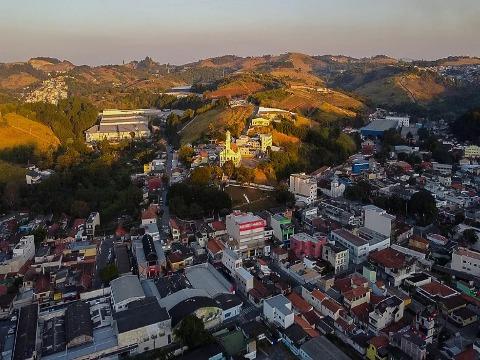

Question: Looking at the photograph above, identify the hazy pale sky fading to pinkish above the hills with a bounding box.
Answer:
[0,0,480,64]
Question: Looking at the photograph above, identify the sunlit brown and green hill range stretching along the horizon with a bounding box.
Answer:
[0,52,480,116]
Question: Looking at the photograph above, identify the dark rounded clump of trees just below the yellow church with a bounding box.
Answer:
[168,181,232,219]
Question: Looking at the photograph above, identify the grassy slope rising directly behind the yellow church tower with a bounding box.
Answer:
[179,106,253,144]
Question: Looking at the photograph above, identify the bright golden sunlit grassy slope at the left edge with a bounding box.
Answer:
[0,113,60,151]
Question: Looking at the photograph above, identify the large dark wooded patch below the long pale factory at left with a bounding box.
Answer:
[1,146,141,223]
